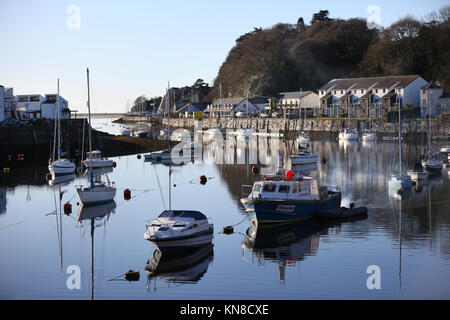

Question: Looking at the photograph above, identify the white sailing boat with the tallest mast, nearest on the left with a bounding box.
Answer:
[77,69,116,206]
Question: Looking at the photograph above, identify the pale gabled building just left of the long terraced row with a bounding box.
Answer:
[278,91,320,116]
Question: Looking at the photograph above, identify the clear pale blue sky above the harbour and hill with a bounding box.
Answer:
[0,0,448,112]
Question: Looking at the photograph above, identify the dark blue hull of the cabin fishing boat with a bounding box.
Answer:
[251,192,342,224]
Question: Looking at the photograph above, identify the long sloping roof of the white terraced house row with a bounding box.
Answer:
[319,75,420,90]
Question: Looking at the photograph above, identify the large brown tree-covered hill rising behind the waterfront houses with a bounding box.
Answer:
[207,6,450,100]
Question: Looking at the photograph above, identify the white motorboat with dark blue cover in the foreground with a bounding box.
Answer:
[144,210,214,250]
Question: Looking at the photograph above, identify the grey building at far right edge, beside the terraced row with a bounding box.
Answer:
[420,82,450,118]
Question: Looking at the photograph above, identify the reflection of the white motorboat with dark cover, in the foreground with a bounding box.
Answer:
[145,243,214,291]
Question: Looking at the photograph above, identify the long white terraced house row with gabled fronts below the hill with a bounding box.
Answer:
[319,75,427,118]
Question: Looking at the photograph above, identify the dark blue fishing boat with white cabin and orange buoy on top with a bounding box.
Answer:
[241,171,342,223]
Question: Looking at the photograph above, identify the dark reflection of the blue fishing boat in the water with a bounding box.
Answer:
[242,216,367,283]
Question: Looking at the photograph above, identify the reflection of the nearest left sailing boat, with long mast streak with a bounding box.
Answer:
[77,200,116,300]
